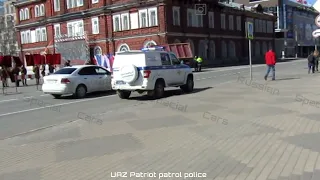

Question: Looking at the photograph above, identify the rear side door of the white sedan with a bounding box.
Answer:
[78,66,99,92]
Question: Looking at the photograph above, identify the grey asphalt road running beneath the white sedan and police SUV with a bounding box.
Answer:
[0,60,307,139]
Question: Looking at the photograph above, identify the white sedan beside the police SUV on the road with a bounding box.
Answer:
[42,65,111,98]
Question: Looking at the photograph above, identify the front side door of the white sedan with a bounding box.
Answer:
[95,67,111,91]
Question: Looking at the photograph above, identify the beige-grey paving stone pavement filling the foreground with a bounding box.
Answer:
[0,72,320,180]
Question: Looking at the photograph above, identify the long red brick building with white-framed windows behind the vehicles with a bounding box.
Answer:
[15,0,275,64]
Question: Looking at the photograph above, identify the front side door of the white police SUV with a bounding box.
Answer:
[170,53,185,84]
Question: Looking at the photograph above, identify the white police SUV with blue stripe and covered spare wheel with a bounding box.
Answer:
[111,48,194,99]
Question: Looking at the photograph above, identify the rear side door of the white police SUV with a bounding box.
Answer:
[160,53,176,85]
